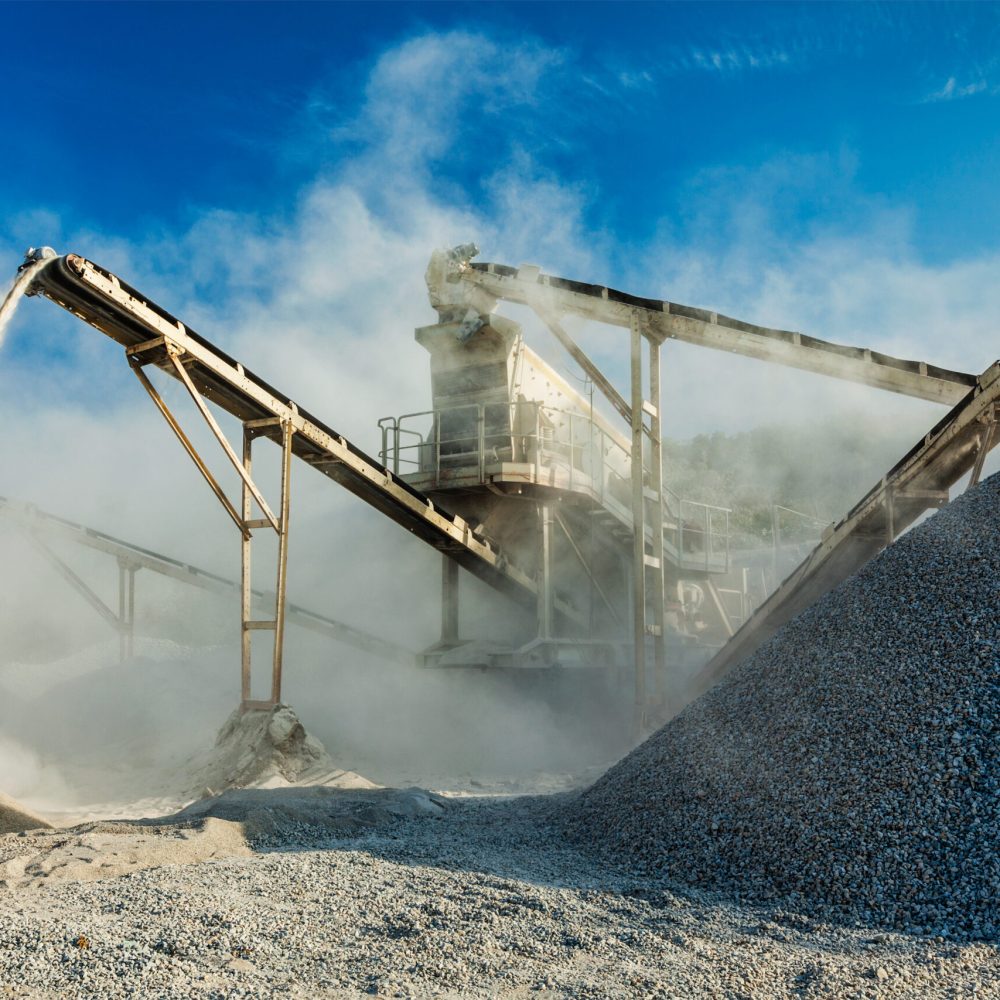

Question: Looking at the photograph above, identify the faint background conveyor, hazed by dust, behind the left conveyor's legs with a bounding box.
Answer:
[0,497,416,666]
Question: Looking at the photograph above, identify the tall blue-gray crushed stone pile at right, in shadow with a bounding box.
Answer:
[567,474,1000,940]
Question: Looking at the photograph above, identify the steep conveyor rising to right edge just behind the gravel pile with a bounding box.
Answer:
[688,361,1000,698]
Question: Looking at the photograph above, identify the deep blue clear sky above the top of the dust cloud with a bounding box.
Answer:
[0,3,1000,261]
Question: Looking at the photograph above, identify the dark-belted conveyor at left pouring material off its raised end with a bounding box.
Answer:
[28,254,575,617]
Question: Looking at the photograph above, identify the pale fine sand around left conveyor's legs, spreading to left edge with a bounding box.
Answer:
[0,705,438,893]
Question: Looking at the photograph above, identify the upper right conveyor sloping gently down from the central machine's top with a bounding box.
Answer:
[455,262,976,405]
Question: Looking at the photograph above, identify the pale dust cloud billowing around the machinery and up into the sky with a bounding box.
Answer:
[0,38,997,814]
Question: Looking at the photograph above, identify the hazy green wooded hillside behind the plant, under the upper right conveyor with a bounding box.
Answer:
[663,416,915,542]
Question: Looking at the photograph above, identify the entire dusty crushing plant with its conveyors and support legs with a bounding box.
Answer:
[3,245,1000,728]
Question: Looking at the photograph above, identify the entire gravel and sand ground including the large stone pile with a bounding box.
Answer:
[0,477,1000,1000]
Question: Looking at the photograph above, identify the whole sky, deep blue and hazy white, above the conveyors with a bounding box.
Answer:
[0,2,1000,564]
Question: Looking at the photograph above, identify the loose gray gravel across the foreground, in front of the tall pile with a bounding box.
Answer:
[0,793,1000,1000]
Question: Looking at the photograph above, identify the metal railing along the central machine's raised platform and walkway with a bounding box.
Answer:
[378,401,731,572]
